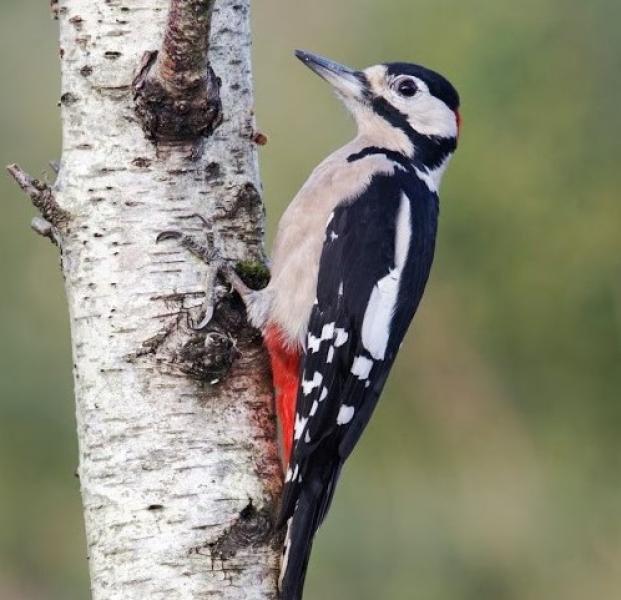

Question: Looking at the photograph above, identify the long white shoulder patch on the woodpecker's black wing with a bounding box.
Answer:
[362,194,412,360]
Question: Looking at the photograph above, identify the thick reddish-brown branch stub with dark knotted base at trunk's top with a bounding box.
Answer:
[134,0,222,148]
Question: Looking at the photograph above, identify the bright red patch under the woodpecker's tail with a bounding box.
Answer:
[263,325,300,468]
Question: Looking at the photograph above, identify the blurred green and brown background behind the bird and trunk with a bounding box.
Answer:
[0,0,621,600]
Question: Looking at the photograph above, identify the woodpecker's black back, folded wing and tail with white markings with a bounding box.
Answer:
[279,170,438,600]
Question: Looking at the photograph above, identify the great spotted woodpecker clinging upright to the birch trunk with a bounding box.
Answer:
[161,51,460,600]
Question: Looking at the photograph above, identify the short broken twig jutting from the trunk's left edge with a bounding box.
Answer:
[7,164,70,245]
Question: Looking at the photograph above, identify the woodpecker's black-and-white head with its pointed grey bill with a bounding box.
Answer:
[296,50,461,169]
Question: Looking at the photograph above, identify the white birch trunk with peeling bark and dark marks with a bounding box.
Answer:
[12,0,281,600]
